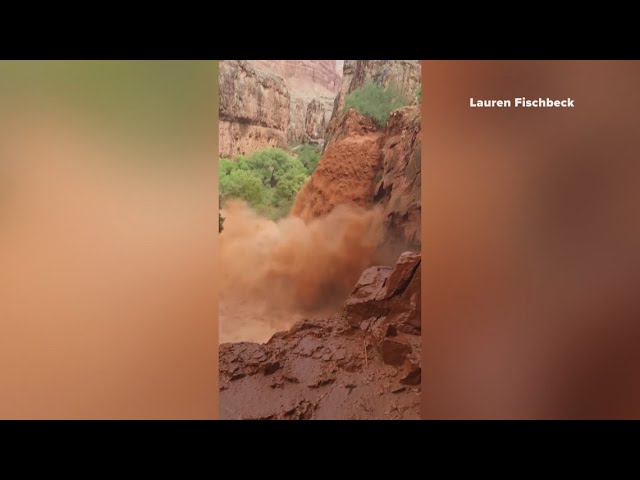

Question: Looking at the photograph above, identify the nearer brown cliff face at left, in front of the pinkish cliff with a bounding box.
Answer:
[218,60,290,158]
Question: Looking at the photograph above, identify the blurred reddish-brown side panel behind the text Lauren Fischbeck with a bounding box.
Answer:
[423,61,640,419]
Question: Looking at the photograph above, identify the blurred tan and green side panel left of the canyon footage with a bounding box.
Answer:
[0,62,218,419]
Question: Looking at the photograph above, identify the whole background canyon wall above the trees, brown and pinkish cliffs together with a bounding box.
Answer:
[219,60,342,157]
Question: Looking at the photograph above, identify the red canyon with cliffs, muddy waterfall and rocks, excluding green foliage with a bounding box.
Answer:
[219,60,421,419]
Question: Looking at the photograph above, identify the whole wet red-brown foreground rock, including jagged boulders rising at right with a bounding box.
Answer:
[220,252,421,420]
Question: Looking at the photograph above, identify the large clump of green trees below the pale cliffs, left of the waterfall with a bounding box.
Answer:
[218,148,308,220]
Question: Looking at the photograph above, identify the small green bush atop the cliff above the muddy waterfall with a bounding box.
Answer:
[344,83,409,127]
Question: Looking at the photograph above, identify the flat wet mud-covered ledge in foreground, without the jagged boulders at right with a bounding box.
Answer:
[220,316,420,420]
